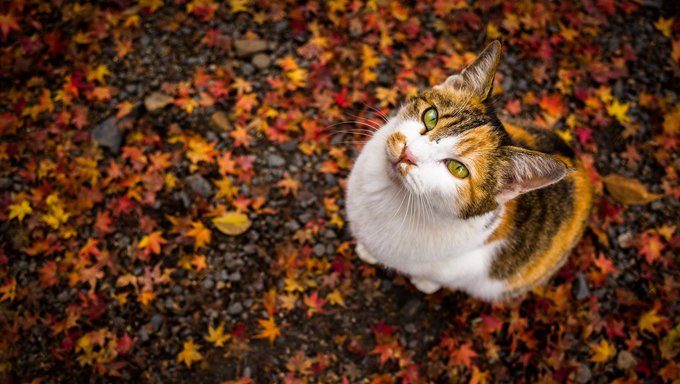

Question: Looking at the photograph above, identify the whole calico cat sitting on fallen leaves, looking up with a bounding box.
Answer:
[347,41,592,300]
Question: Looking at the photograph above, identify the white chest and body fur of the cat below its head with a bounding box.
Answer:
[347,123,505,300]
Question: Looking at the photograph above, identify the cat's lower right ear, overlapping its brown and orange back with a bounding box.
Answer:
[497,146,570,202]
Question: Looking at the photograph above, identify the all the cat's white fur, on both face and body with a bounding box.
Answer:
[347,117,505,300]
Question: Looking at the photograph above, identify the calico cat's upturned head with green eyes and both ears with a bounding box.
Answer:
[385,41,568,218]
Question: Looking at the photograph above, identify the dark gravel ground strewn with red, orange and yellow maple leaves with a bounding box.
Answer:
[0,0,680,383]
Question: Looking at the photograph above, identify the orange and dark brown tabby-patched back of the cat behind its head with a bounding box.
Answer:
[490,121,592,295]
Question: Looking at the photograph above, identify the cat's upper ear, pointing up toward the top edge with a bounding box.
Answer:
[439,40,501,101]
